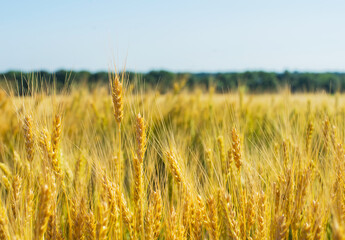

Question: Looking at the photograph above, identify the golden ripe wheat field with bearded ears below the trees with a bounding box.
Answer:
[0,75,345,240]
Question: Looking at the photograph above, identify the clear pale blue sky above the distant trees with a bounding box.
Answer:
[0,0,345,72]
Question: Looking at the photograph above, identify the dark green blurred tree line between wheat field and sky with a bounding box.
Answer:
[0,70,345,93]
